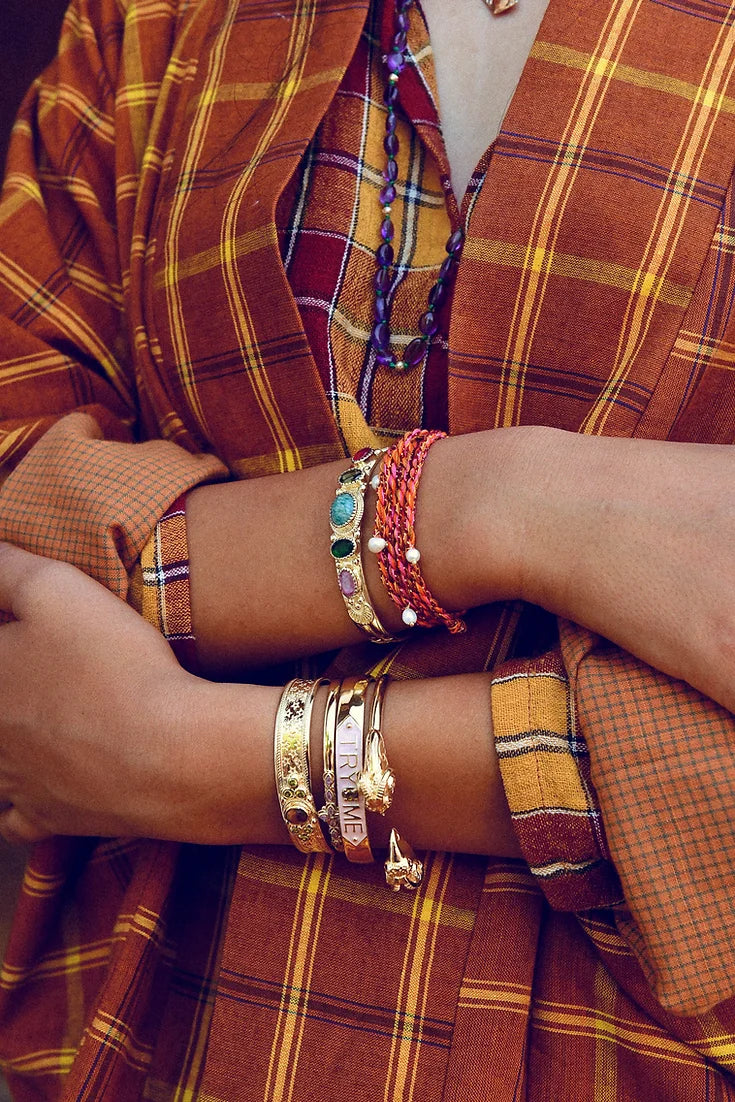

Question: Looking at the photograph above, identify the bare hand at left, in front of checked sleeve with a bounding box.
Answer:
[0,543,206,842]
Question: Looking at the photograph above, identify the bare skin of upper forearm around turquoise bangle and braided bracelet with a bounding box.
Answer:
[186,429,529,676]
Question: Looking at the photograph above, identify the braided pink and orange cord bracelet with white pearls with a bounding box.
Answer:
[368,429,466,635]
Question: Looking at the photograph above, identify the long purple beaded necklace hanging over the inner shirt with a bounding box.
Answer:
[370,0,464,371]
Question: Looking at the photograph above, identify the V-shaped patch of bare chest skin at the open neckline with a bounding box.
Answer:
[422,0,547,201]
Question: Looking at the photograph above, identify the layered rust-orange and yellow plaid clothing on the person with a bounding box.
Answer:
[0,0,735,1102]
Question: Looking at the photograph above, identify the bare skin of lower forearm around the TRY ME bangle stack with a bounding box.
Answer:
[180,673,520,857]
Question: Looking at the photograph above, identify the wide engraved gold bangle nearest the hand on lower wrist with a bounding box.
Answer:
[273,678,331,853]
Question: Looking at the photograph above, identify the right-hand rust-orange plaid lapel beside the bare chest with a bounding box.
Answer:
[448,0,735,435]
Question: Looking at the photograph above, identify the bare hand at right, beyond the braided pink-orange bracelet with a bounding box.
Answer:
[511,430,735,712]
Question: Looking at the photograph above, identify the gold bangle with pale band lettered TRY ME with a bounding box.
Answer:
[334,678,374,865]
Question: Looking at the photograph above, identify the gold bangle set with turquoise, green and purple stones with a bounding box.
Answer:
[329,447,399,642]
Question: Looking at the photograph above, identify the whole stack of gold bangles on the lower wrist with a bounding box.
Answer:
[273,677,423,892]
